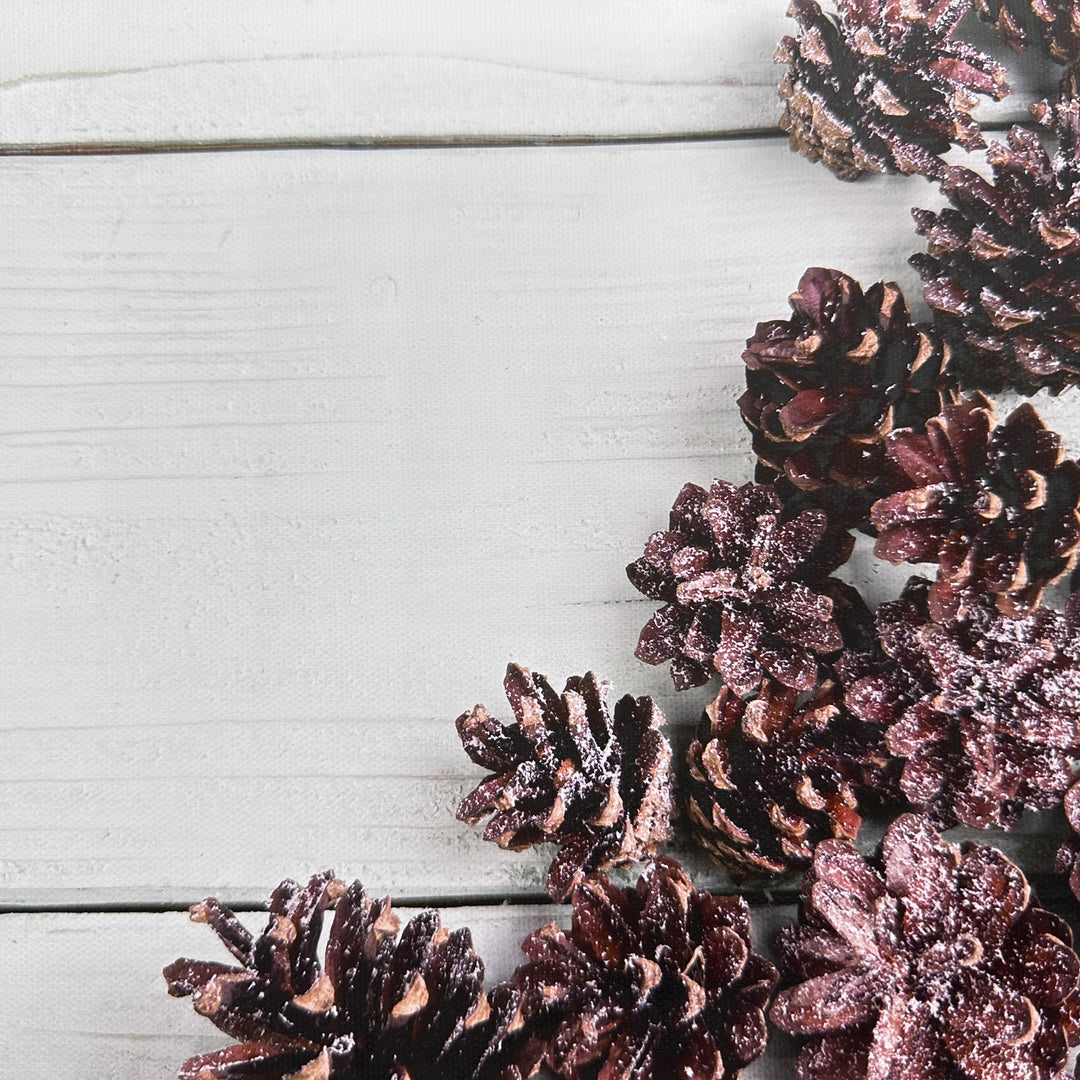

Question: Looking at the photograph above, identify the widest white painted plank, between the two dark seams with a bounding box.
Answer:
[0,140,1080,905]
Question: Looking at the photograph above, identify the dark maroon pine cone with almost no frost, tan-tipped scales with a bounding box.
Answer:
[739,267,948,527]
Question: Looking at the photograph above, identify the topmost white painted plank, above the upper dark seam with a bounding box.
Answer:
[0,0,1058,148]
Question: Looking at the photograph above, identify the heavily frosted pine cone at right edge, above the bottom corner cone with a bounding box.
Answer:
[845,578,1080,828]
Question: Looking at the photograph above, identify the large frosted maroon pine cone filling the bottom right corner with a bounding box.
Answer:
[770,814,1080,1080]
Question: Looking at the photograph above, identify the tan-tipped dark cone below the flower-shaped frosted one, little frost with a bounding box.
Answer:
[687,680,891,874]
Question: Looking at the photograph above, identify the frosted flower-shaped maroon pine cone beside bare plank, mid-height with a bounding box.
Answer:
[626,480,854,693]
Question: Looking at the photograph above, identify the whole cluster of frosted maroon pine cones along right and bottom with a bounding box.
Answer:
[165,0,1080,1080]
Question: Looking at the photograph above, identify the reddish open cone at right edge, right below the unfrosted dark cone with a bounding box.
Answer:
[870,393,1080,621]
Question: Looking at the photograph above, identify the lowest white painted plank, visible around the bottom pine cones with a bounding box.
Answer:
[0,906,794,1080]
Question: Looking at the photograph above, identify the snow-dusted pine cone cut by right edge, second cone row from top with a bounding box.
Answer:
[910,76,1080,394]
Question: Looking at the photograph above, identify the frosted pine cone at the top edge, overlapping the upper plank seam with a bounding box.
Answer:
[775,0,1009,180]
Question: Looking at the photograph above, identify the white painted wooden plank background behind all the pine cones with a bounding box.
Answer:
[0,0,1080,1080]
